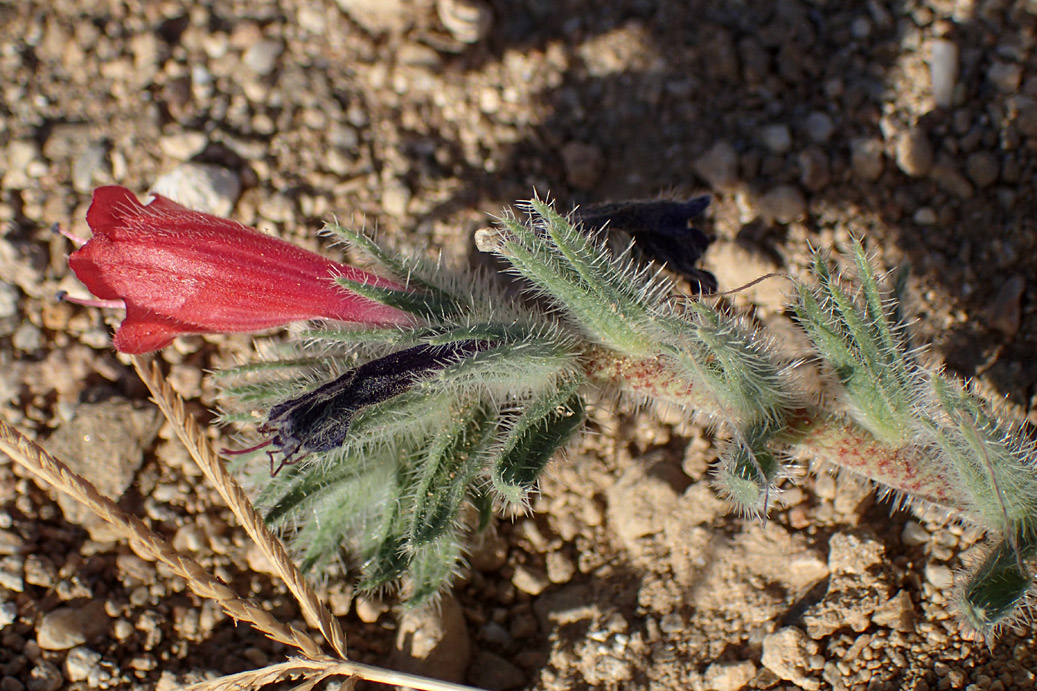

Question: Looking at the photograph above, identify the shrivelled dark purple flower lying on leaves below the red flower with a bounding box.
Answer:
[257,340,492,473]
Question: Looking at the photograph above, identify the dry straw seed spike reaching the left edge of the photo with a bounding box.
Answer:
[0,419,320,658]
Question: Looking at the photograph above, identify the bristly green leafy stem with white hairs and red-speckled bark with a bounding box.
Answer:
[212,198,1037,636]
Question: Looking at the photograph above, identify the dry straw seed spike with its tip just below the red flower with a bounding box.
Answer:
[133,356,348,660]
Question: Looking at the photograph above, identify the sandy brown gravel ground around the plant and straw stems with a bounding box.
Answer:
[0,0,1037,691]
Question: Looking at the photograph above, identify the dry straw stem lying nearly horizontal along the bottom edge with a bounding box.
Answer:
[184,658,487,691]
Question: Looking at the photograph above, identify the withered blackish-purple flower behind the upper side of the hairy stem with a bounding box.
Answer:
[574,196,717,293]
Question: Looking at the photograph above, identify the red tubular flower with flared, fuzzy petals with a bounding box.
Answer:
[62,186,412,353]
